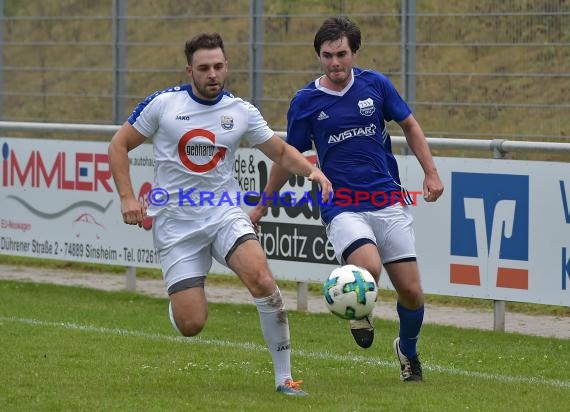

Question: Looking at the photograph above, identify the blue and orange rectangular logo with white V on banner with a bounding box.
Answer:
[450,172,529,290]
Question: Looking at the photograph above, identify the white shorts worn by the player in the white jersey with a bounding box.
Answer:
[152,207,255,289]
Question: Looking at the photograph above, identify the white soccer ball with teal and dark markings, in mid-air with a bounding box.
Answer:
[323,265,378,319]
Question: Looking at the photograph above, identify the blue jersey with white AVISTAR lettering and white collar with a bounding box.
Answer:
[287,67,412,223]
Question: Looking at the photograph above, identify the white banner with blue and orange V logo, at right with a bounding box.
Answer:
[405,158,570,306]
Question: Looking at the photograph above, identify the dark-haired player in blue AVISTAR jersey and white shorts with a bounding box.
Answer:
[250,17,443,381]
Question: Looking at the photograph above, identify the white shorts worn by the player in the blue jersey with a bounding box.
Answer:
[326,205,416,264]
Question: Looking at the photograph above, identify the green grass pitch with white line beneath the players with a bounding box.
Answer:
[0,281,570,412]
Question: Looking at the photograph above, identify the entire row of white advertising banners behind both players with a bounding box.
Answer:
[0,138,570,306]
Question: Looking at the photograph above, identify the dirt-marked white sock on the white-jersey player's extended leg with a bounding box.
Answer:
[253,288,291,387]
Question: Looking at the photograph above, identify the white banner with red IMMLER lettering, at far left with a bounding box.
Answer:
[0,138,158,267]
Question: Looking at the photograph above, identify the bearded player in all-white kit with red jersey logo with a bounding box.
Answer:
[109,33,332,396]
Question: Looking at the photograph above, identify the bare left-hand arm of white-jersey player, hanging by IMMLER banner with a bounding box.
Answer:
[108,122,146,226]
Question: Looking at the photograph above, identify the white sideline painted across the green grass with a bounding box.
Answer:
[4,316,570,388]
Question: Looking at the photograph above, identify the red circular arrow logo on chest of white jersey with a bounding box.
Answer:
[178,129,226,173]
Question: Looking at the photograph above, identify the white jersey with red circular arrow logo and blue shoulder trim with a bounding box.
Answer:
[128,85,274,219]
